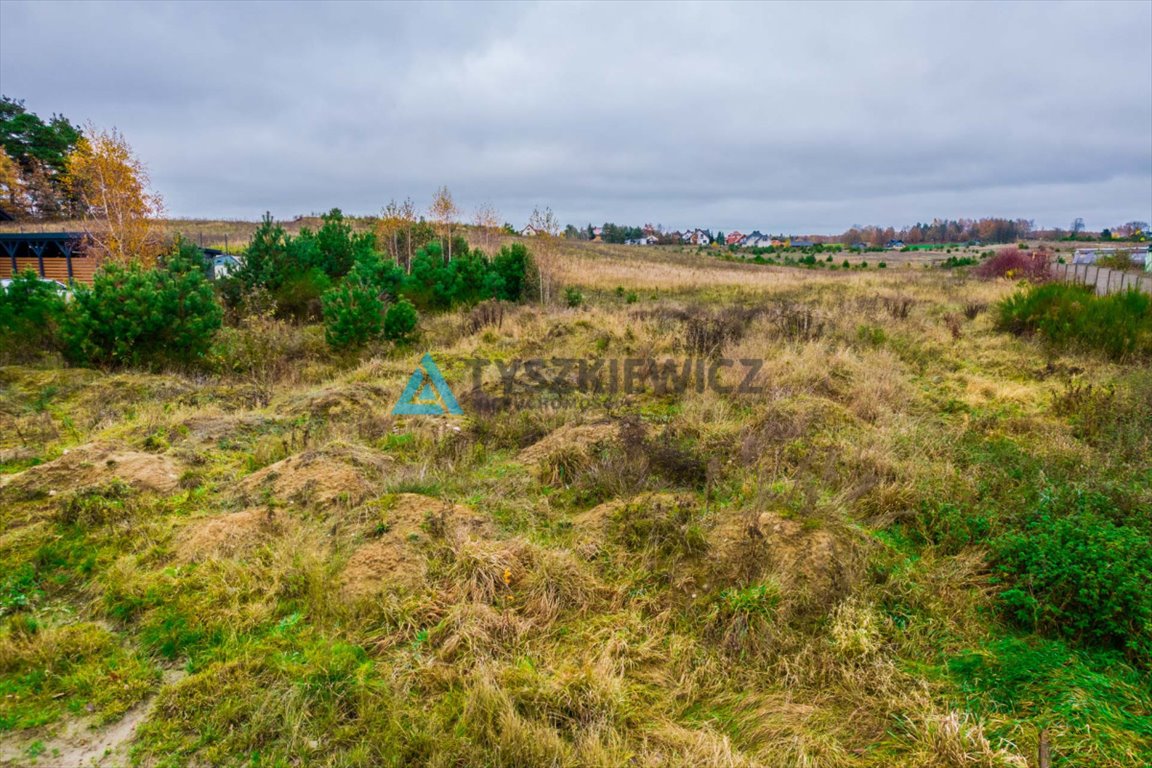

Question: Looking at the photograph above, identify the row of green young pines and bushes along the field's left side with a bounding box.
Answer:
[0,210,533,367]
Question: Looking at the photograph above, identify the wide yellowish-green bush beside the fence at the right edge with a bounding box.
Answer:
[996,283,1152,359]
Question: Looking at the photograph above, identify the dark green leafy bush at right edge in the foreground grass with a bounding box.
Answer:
[992,503,1152,661]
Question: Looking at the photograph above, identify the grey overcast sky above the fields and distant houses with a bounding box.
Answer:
[0,0,1152,234]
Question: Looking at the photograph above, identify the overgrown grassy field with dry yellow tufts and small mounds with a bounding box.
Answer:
[0,243,1152,768]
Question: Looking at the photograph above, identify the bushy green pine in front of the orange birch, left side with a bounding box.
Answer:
[61,242,223,365]
